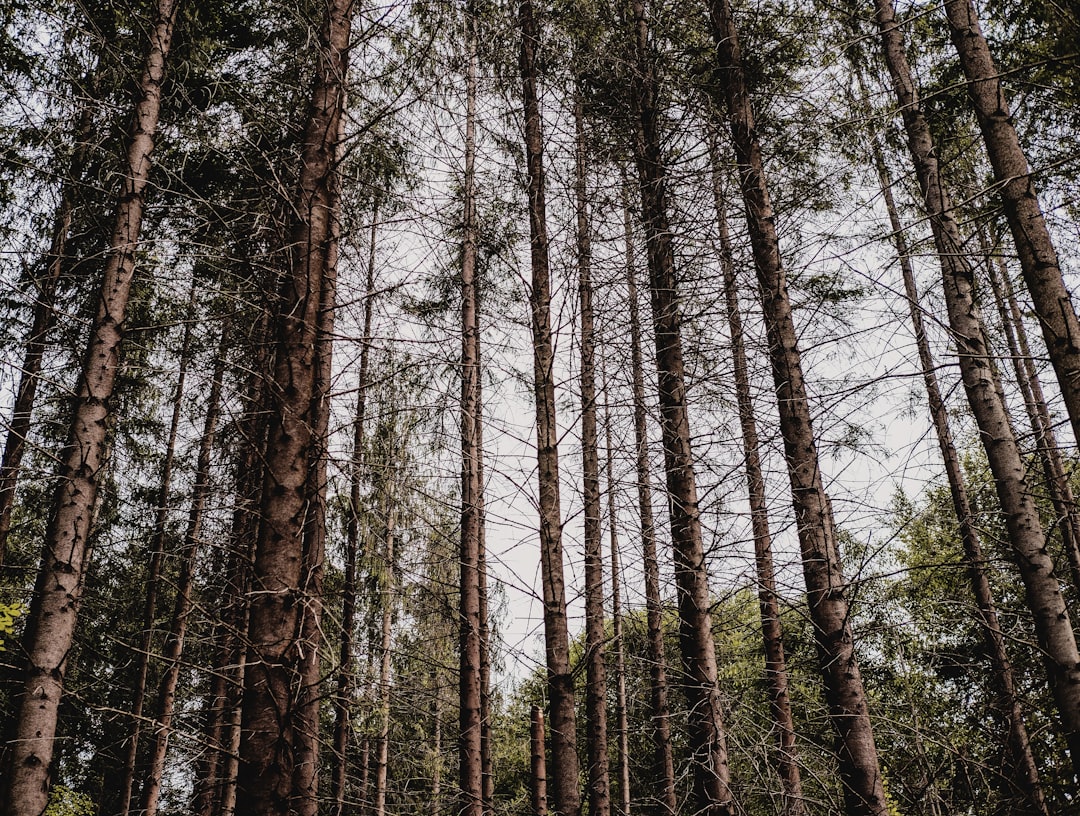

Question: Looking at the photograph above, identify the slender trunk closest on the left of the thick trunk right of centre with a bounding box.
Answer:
[623,187,677,816]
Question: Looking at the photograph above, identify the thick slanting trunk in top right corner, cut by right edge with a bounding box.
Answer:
[945,0,1080,443]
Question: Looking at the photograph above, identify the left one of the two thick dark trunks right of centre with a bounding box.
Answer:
[632,0,734,816]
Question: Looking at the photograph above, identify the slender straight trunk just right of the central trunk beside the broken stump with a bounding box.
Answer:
[573,90,611,816]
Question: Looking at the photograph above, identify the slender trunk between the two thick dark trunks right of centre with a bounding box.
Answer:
[708,133,807,816]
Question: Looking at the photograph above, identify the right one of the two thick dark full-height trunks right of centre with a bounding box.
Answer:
[710,0,888,816]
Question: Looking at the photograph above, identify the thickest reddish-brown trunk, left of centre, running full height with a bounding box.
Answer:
[238,0,352,816]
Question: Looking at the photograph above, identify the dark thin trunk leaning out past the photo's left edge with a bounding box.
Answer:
[0,84,96,561]
